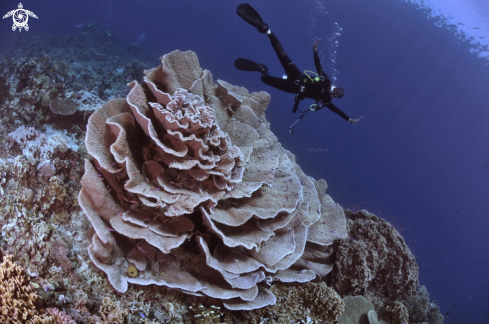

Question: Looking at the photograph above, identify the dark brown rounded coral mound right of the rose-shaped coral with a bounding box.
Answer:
[332,210,418,310]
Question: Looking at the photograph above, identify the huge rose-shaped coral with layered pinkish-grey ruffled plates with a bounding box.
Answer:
[79,51,347,310]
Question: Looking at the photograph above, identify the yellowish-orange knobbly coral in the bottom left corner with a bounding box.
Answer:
[0,255,55,324]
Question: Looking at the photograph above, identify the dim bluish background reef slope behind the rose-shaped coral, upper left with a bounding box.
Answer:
[0,29,148,140]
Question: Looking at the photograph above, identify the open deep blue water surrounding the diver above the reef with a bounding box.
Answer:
[0,0,489,323]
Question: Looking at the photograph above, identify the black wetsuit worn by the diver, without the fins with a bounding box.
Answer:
[261,31,350,121]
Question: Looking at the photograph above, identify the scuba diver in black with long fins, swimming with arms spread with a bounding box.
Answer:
[234,3,363,134]
